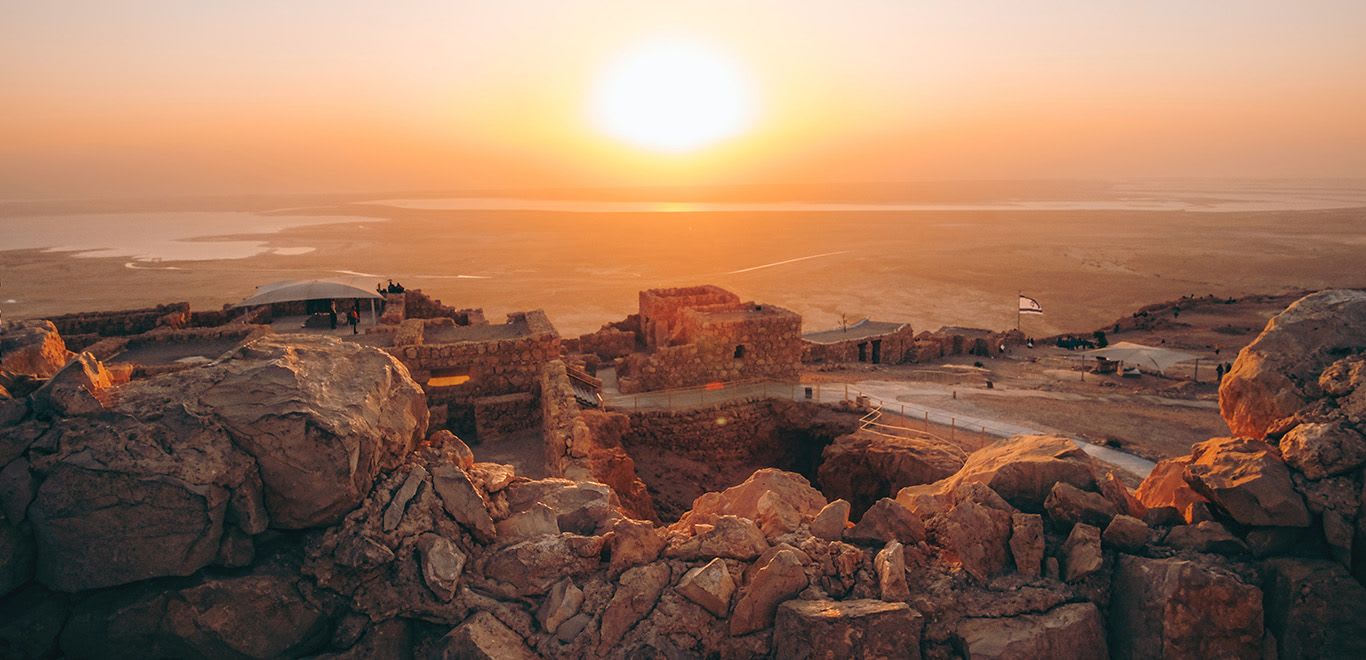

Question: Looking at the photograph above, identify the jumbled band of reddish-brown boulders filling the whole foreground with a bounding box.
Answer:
[0,291,1366,659]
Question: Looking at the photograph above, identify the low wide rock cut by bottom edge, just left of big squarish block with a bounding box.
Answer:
[958,603,1109,660]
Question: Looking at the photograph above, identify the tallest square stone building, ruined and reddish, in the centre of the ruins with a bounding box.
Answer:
[617,286,802,392]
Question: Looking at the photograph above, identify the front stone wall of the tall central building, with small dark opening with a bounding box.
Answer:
[617,303,802,392]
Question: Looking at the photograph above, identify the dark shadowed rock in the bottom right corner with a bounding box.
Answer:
[1262,559,1366,657]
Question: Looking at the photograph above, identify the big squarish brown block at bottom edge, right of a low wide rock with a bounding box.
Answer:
[1109,555,1262,660]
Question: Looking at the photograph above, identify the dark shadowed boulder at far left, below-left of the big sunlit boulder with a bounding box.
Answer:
[29,409,256,592]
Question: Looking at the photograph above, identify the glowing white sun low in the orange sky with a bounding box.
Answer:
[590,38,754,153]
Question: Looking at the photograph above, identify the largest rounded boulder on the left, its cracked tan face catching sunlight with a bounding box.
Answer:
[198,335,428,529]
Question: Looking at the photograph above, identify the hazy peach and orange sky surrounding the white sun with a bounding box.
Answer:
[0,0,1366,197]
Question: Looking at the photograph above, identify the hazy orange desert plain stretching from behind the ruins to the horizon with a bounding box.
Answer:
[0,200,1366,335]
